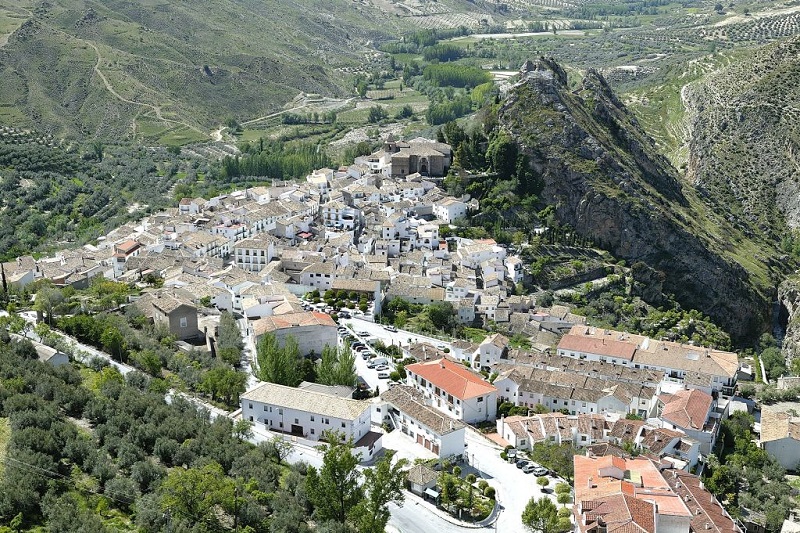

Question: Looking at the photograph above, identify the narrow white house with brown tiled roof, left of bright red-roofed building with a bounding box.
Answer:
[377,385,466,457]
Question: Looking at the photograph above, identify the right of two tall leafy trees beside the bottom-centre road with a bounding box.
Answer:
[354,451,406,533]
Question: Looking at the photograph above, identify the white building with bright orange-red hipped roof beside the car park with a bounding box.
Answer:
[406,359,497,423]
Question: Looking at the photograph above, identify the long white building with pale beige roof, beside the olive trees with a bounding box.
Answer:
[241,383,381,460]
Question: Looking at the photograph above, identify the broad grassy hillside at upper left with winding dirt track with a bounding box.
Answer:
[0,0,494,143]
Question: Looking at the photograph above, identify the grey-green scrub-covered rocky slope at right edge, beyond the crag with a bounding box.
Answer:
[684,37,800,234]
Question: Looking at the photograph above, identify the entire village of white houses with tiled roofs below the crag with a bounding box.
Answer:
[2,137,800,533]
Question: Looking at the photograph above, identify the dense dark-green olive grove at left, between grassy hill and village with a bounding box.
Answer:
[0,132,182,259]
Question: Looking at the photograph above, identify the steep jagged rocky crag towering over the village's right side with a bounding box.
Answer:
[500,59,770,341]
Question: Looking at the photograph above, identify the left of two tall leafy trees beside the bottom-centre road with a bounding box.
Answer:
[305,433,364,523]
